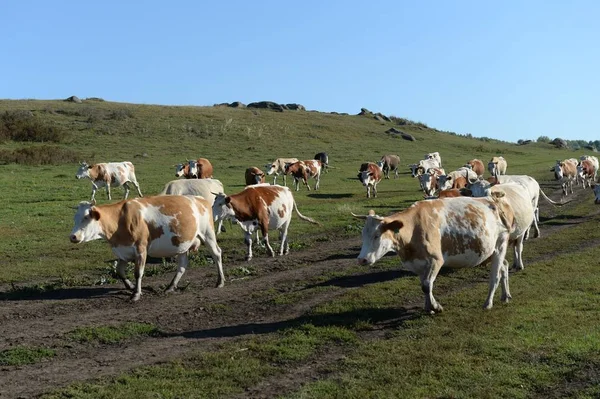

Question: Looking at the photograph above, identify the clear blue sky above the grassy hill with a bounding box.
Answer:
[0,0,600,141]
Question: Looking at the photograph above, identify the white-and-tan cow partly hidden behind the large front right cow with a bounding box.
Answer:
[469,180,537,270]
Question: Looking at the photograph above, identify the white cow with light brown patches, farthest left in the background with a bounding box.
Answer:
[75,162,143,201]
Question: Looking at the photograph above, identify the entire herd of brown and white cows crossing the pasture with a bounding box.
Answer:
[70,152,600,313]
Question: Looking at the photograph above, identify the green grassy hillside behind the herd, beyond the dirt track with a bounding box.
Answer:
[0,100,578,282]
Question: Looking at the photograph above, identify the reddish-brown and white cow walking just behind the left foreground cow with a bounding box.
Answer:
[213,184,319,261]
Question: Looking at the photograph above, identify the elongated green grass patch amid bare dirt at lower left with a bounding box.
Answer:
[67,322,160,345]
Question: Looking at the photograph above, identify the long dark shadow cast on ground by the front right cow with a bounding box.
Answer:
[167,307,425,339]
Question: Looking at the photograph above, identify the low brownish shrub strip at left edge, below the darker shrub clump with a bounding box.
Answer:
[0,145,81,166]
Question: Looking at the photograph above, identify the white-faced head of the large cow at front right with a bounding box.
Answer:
[352,210,403,265]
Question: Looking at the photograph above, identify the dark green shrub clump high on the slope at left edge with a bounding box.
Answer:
[0,111,66,143]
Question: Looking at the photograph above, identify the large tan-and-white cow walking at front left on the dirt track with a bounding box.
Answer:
[70,195,225,301]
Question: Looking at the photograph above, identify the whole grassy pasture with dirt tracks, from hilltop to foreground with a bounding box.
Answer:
[0,100,600,398]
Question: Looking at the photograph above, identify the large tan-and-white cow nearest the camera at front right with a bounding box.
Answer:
[352,193,514,313]
